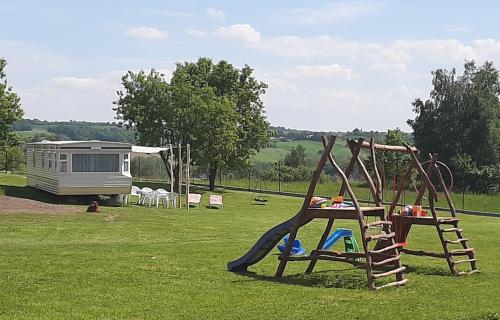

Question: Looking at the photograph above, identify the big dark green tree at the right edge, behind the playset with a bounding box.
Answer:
[408,61,500,194]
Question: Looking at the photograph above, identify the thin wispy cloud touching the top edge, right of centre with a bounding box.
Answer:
[288,1,380,25]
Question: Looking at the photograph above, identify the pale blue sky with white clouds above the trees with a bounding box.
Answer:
[0,0,500,131]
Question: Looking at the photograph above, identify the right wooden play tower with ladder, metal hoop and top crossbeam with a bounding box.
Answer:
[368,140,479,276]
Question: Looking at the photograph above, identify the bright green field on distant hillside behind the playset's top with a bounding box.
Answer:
[251,139,351,163]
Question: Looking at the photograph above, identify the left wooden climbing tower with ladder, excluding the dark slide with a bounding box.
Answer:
[276,136,408,289]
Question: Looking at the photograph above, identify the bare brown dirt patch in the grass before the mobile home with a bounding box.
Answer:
[0,196,82,213]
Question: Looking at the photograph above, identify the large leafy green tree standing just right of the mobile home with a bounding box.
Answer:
[114,58,269,190]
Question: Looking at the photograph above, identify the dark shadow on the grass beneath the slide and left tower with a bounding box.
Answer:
[233,269,367,289]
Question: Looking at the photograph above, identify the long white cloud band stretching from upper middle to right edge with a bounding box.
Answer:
[216,24,500,67]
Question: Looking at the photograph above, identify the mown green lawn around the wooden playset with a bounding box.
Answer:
[0,175,500,319]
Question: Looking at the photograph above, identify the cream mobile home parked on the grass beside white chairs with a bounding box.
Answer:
[26,140,132,195]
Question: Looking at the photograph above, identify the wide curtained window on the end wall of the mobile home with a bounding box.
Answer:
[71,154,120,172]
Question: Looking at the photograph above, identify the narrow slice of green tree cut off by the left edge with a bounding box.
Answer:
[0,58,23,170]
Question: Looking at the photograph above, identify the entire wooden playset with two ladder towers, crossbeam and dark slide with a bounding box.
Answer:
[227,136,477,289]
